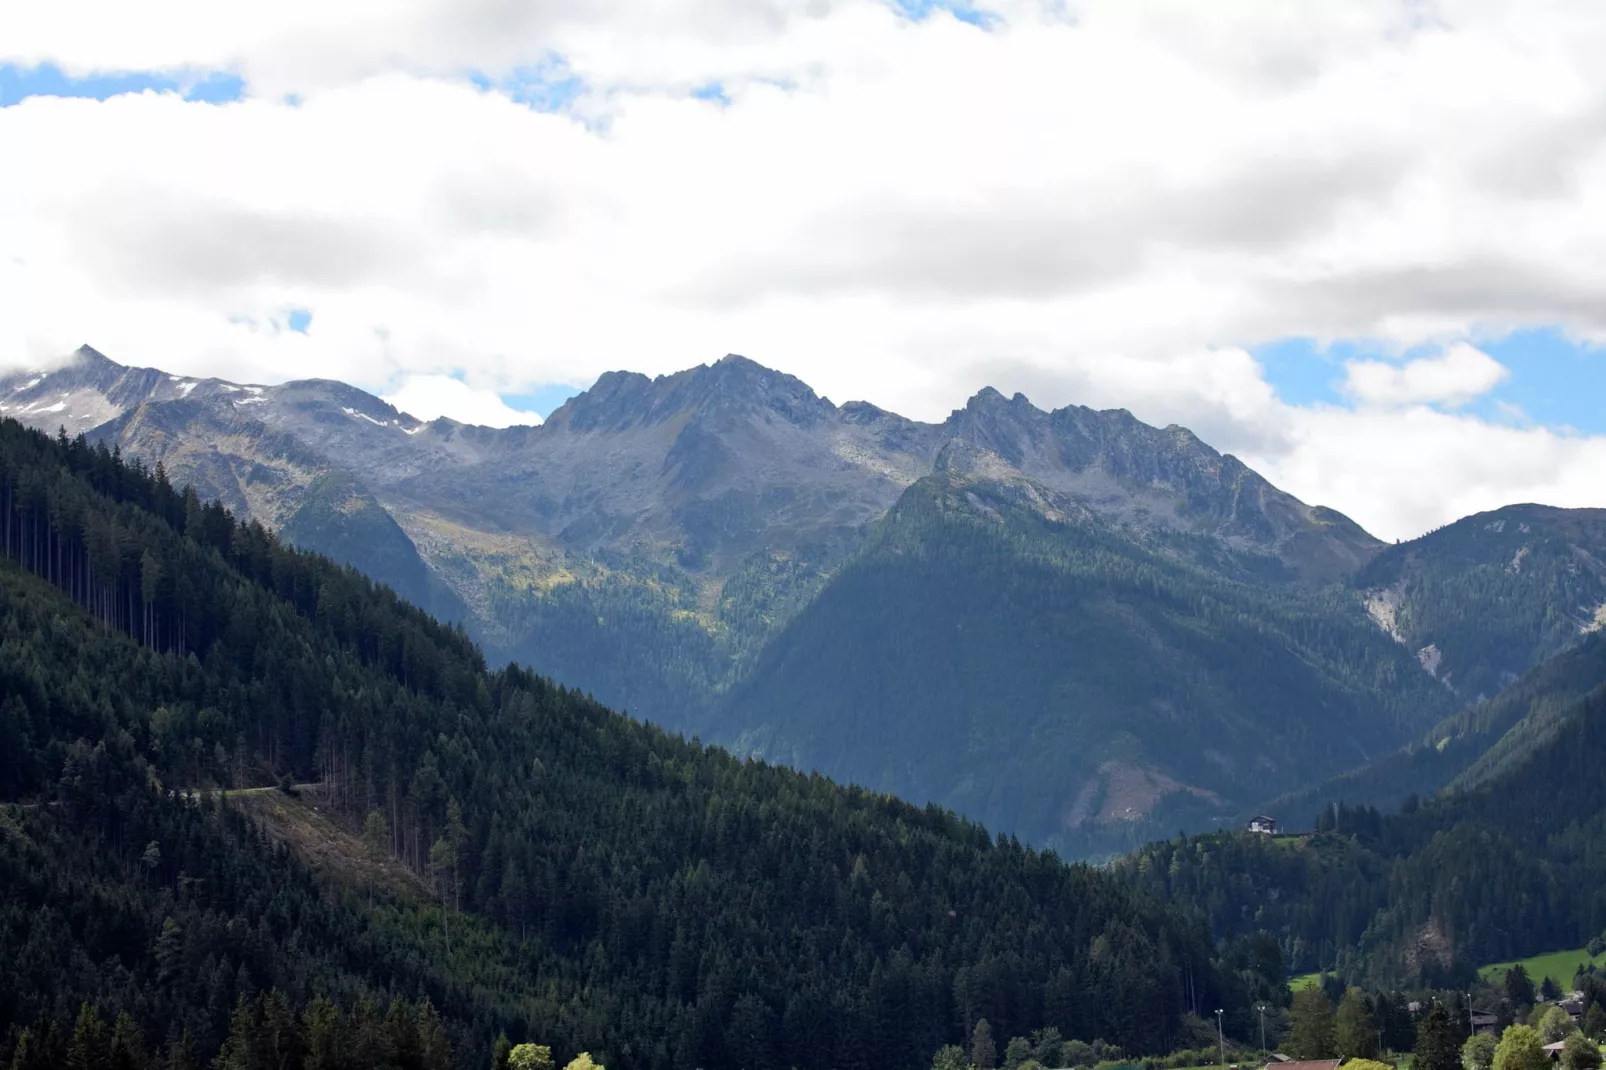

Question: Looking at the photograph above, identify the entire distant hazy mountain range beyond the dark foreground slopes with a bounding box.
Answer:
[0,347,1606,853]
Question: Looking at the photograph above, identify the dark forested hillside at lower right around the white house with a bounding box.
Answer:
[1118,629,1606,985]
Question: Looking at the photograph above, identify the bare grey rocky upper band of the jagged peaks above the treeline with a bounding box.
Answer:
[0,347,1380,591]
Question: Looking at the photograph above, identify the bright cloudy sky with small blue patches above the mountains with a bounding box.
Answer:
[0,0,1606,538]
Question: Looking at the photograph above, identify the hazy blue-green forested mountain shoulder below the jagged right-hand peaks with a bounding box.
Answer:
[715,476,1453,853]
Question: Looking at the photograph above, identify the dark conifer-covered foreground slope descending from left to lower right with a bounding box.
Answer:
[0,423,1264,1070]
